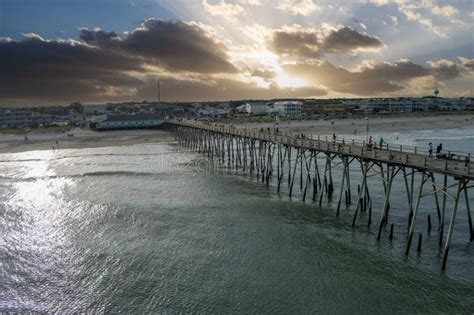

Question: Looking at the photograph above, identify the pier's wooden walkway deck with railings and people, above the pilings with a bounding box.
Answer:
[169,120,474,179]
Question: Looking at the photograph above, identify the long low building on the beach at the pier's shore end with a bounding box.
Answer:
[95,114,165,130]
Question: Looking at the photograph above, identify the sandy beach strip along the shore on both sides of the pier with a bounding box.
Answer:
[0,115,474,153]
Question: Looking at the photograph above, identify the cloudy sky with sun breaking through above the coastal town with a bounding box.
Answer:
[0,0,474,105]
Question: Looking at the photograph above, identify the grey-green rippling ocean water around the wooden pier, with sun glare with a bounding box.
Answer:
[0,128,474,313]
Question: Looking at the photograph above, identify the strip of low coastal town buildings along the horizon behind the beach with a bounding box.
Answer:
[0,96,474,131]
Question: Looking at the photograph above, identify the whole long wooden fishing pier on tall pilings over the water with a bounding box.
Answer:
[165,120,474,270]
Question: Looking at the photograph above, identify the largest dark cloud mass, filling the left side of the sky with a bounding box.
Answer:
[0,20,236,103]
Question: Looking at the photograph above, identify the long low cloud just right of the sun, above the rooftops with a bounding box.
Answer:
[285,61,428,96]
